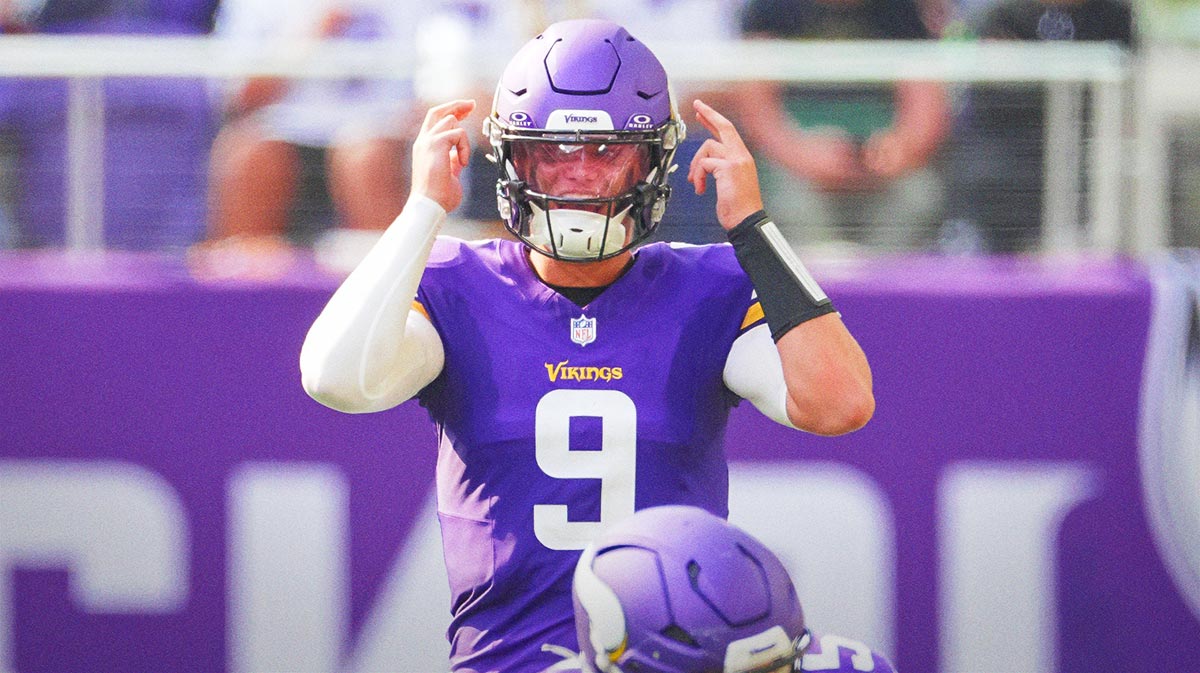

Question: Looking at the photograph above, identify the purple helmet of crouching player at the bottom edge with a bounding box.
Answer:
[574,505,809,673]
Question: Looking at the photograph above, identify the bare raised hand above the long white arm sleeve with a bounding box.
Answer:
[413,100,475,212]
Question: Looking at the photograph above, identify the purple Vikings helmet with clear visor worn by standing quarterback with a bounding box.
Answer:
[484,19,685,262]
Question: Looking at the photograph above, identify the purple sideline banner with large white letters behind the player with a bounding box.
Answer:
[0,254,1200,673]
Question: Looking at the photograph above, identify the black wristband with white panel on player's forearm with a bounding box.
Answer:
[727,210,836,341]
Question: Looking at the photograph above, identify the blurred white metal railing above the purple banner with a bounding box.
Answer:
[0,35,1128,252]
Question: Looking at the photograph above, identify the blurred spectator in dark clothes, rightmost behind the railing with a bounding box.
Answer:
[947,0,1132,253]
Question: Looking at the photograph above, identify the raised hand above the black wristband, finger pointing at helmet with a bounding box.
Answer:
[688,100,762,230]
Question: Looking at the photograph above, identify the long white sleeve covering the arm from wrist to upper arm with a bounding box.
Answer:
[300,197,446,414]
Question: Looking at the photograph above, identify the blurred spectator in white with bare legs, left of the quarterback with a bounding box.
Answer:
[200,0,425,275]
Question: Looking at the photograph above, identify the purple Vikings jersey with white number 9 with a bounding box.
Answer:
[418,239,762,673]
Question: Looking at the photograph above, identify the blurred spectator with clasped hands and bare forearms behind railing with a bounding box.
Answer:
[738,0,949,250]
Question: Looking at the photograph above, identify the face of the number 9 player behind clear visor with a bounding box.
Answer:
[514,143,650,198]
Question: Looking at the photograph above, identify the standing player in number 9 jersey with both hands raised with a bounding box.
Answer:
[300,20,875,673]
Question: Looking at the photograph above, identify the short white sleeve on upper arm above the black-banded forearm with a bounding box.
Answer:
[722,324,796,427]
